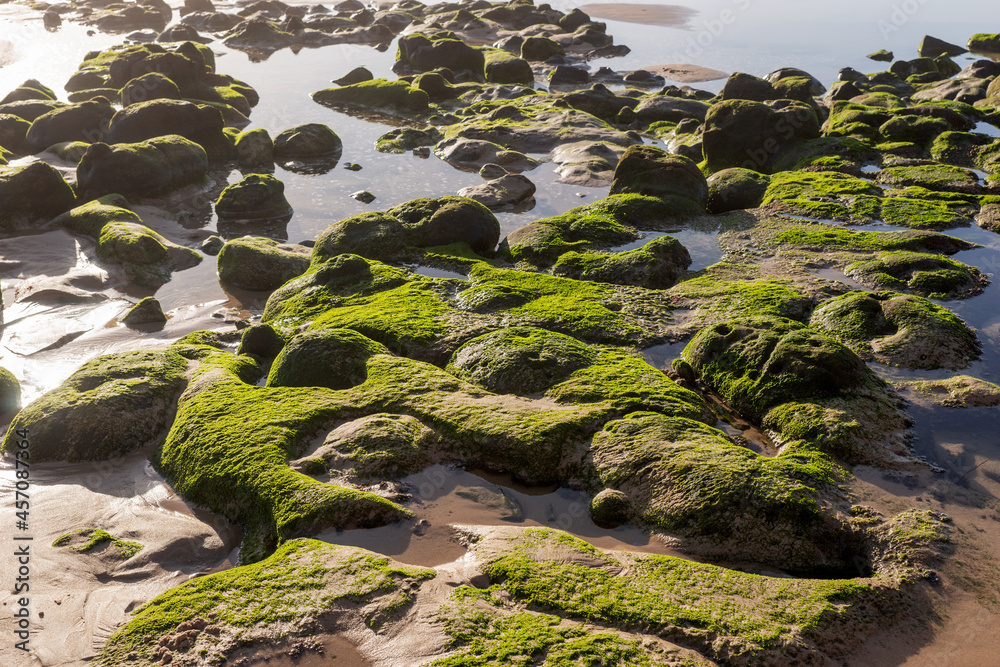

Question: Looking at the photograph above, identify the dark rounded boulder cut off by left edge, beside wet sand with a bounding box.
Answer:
[0,162,76,231]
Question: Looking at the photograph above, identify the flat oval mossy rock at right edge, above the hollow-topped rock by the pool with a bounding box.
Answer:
[845,251,989,299]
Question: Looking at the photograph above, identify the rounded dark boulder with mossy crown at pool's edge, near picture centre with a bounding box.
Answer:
[388,195,500,254]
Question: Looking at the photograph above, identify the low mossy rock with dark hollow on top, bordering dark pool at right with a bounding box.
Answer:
[809,292,980,370]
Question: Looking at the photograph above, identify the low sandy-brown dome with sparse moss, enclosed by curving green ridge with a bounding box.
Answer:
[292,413,440,482]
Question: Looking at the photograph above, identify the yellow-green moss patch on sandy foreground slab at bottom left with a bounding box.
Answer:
[99,540,434,667]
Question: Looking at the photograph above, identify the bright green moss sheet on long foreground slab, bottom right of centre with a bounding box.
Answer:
[476,531,873,660]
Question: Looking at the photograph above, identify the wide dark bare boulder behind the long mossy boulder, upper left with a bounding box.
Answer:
[105,100,232,159]
